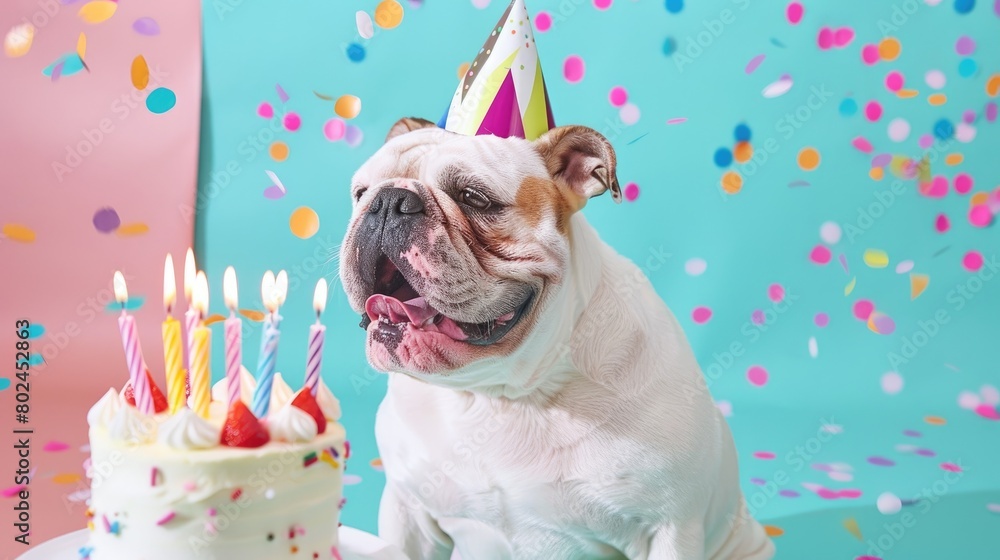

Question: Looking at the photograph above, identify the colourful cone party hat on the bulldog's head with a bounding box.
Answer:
[438,0,555,140]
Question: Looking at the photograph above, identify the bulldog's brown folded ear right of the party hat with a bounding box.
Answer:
[534,126,622,206]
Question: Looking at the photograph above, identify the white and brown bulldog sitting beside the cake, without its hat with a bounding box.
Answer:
[340,118,774,560]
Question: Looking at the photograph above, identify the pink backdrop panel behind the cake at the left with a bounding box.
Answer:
[0,0,201,558]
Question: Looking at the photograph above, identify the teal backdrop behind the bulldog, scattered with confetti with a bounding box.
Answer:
[197,0,1000,558]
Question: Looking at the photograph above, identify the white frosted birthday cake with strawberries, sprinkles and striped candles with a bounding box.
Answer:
[79,260,350,560]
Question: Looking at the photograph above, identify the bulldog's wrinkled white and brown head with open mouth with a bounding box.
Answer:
[340,119,620,374]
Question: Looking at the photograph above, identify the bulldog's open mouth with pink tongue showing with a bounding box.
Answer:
[361,255,531,345]
